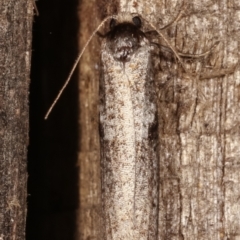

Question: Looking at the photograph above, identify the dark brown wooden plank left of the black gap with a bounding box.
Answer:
[0,0,33,240]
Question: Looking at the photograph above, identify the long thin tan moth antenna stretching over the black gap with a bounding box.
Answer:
[44,16,114,120]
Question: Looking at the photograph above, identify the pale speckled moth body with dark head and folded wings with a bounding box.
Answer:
[100,13,158,239]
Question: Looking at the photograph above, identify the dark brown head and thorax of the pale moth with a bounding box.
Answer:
[106,14,147,62]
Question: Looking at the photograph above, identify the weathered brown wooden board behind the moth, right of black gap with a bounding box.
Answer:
[78,0,240,240]
